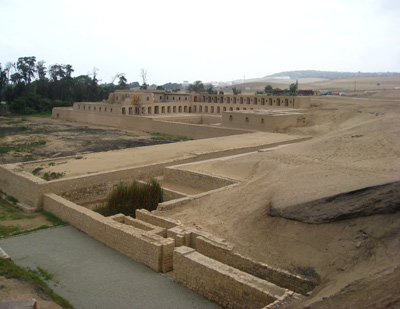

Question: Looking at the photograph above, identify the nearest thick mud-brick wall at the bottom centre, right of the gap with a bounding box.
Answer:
[174,246,286,308]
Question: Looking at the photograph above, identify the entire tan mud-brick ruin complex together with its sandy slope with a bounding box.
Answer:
[0,83,400,308]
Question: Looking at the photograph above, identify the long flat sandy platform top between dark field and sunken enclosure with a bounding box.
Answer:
[24,132,302,178]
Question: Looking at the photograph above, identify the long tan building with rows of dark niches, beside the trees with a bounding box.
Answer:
[73,90,310,116]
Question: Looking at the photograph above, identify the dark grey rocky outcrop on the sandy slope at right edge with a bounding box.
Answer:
[269,181,400,223]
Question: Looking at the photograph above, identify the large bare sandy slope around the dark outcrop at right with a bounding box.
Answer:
[155,97,400,306]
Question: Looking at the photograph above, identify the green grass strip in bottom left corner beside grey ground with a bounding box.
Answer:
[0,258,73,308]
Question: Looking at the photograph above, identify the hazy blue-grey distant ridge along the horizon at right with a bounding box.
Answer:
[265,70,400,79]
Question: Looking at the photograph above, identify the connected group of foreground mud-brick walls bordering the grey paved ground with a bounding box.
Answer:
[39,197,315,308]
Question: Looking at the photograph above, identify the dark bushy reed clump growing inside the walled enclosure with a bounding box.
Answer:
[98,179,164,218]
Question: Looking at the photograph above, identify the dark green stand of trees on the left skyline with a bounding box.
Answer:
[0,56,156,114]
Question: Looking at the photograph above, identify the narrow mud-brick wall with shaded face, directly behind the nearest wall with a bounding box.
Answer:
[196,236,317,295]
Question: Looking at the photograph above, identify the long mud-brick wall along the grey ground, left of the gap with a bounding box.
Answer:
[43,193,175,272]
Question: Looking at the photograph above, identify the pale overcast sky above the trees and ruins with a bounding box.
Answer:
[0,0,400,84]
